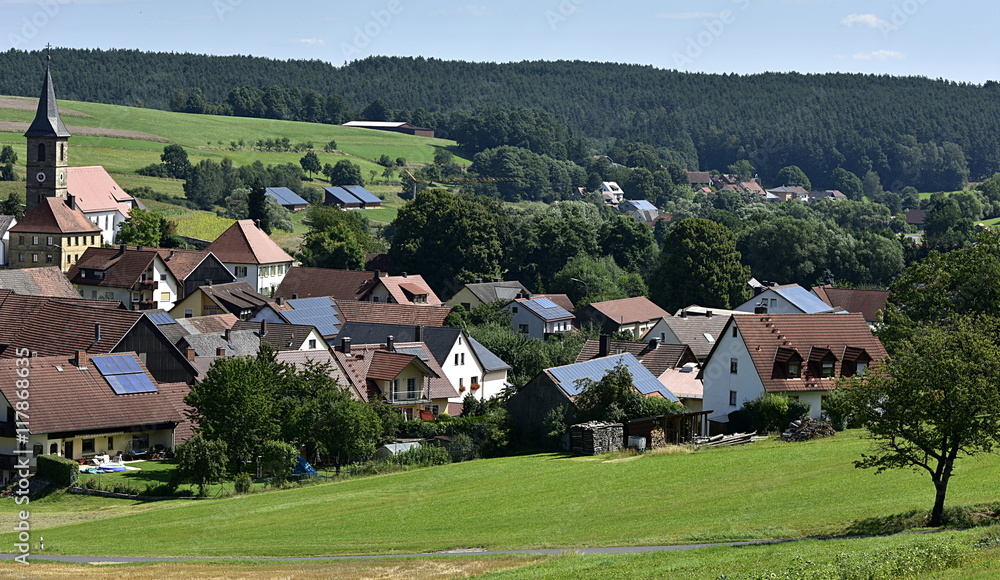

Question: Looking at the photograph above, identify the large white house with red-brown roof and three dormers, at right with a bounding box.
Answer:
[699,313,886,432]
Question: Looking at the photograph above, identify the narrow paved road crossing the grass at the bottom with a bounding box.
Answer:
[0,538,796,564]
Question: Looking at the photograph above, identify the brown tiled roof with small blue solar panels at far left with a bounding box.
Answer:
[0,353,183,434]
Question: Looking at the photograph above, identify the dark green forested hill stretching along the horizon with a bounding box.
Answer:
[0,49,1000,187]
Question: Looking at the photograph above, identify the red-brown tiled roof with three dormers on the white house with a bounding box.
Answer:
[730,313,886,392]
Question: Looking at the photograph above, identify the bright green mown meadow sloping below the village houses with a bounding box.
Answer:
[7,432,1000,556]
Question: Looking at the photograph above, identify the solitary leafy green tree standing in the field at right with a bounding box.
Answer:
[843,316,1000,526]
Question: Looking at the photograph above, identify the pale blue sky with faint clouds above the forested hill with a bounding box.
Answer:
[0,0,1000,83]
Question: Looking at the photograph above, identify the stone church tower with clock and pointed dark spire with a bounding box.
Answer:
[24,49,70,211]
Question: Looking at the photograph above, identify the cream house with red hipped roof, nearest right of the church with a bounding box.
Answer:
[206,220,294,296]
